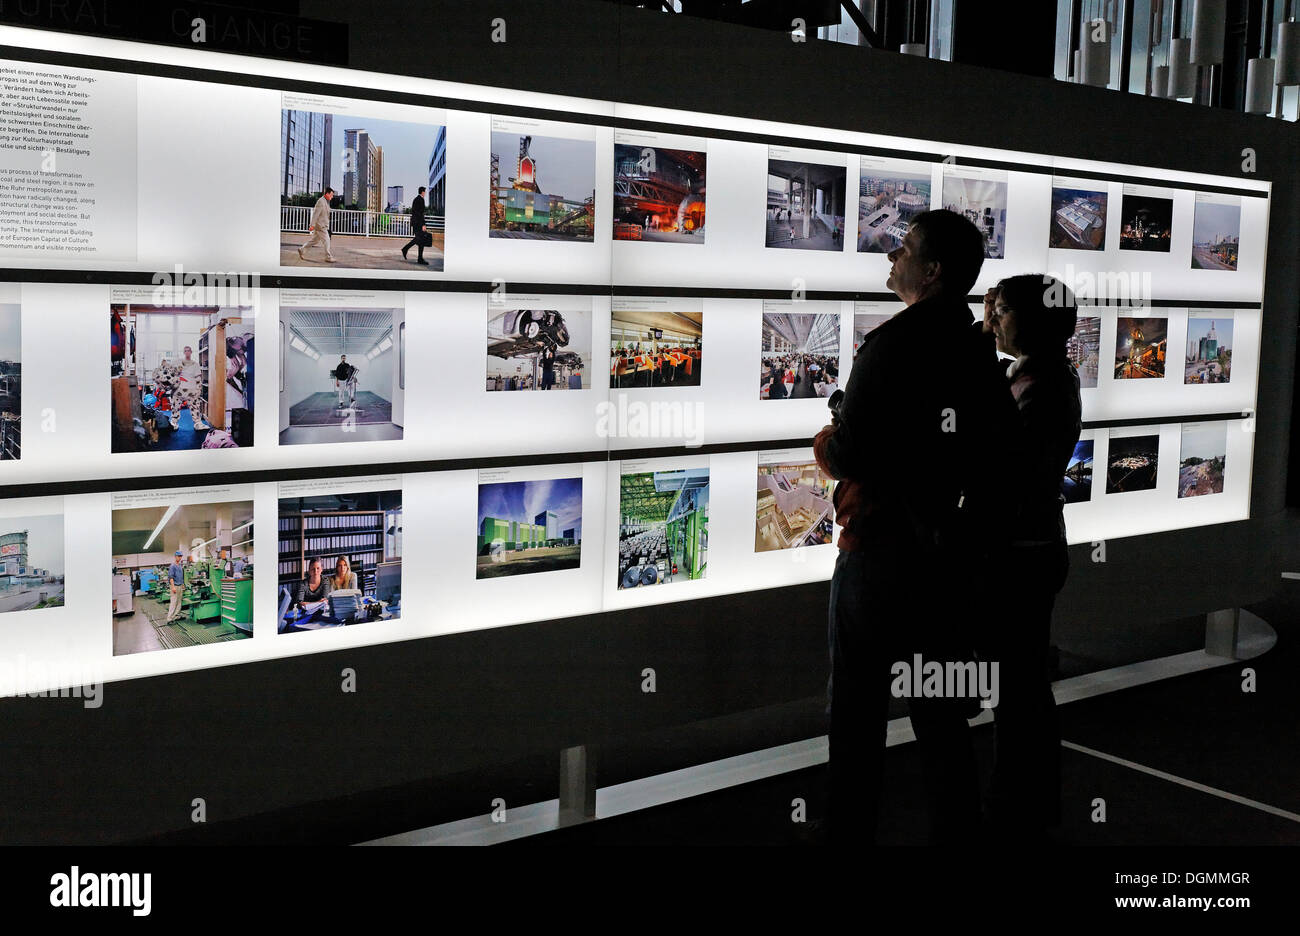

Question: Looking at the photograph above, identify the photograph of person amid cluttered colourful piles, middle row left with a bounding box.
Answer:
[108,302,255,452]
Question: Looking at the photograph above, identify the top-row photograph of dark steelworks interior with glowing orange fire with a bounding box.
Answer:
[614,143,706,244]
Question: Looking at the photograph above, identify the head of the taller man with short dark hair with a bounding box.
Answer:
[885,208,984,306]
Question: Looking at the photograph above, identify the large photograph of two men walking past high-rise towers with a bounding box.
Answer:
[280,95,447,270]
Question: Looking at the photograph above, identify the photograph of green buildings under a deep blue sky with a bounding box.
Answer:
[475,477,582,579]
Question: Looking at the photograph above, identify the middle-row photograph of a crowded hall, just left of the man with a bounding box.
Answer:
[758,308,840,399]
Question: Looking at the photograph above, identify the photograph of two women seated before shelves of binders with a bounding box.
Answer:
[276,481,402,633]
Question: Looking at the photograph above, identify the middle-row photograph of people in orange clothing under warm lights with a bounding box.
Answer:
[610,299,705,390]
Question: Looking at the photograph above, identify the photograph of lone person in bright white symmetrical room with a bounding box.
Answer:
[280,306,406,445]
